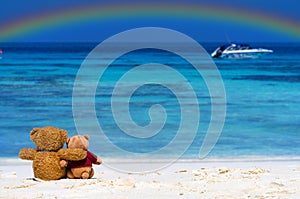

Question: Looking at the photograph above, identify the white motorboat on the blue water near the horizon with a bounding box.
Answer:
[211,43,273,59]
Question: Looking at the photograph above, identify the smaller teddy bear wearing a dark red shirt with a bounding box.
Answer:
[67,135,102,179]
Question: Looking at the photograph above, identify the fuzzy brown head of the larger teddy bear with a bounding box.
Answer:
[30,126,68,151]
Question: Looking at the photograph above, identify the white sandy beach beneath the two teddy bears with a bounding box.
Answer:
[0,159,300,199]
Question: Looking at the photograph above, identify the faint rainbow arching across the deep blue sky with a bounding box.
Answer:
[0,3,300,41]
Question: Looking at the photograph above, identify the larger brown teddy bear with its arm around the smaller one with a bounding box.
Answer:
[19,126,87,180]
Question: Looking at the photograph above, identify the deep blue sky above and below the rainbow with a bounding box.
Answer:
[0,0,300,42]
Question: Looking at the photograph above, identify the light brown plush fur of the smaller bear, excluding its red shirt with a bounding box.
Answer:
[67,135,102,179]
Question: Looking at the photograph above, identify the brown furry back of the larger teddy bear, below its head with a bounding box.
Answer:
[32,152,66,180]
